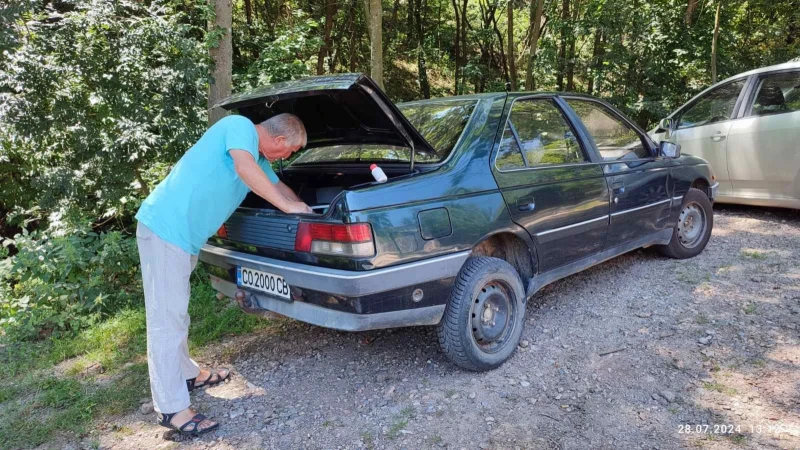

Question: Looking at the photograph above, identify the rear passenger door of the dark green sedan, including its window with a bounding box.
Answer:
[493,96,609,272]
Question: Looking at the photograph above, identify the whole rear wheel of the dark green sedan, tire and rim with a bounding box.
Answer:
[437,256,525,372]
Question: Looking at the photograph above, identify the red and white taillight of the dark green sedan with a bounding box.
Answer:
[294,222,375,256]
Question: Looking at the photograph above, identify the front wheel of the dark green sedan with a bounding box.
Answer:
[658,188,714,259]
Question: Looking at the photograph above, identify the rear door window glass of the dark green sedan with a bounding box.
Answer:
[496,99,586,170]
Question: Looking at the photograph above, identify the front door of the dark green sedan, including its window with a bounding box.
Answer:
[565,97,672,248]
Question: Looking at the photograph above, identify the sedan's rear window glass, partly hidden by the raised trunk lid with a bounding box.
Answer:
[292,100,476,164]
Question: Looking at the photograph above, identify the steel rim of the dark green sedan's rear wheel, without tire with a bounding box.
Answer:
[469,281,518,353]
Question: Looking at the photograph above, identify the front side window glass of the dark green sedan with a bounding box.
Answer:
[567,99,651,161]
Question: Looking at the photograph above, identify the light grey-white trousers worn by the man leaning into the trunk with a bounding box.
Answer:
[136,223,200,414]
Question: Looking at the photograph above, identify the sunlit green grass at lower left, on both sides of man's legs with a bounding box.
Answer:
[0,282,269,448]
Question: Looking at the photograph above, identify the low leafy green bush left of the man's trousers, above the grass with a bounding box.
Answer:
[0,231,142,339]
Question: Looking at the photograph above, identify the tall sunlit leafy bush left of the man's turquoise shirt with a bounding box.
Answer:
[0,0,207,231]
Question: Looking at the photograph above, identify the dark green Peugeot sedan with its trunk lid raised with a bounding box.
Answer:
[200,74,717,371]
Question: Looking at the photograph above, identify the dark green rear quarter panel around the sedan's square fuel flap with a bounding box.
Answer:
[344,94,527,268]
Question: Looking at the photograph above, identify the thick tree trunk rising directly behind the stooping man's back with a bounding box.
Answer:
[208,0,233,125]
